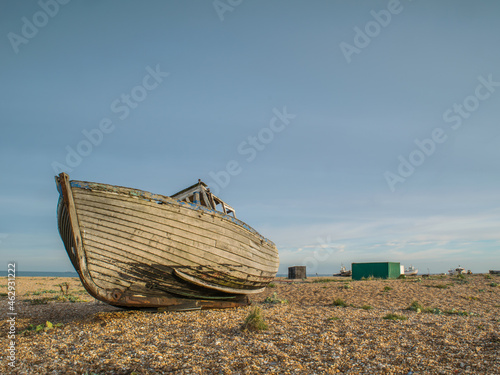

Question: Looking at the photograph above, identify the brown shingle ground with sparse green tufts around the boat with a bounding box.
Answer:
[0,275,500,375]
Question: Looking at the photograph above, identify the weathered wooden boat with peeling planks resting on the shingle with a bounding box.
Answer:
[56,173,279,310]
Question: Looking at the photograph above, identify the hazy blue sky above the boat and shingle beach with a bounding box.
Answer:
[0,0,500,274]
